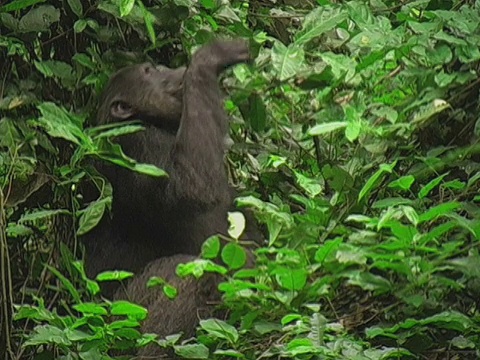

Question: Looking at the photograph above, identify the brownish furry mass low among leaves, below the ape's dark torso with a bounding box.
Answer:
[114,255,220,359]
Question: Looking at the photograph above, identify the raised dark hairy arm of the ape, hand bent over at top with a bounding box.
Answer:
[168,40,249,209]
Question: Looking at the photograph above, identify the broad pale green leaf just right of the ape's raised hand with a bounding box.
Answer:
[272,40,305,81]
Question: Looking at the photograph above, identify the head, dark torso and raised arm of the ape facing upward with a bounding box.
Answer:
[84,40,253,275]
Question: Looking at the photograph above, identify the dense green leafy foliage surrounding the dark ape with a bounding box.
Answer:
[0,0,480,359]
